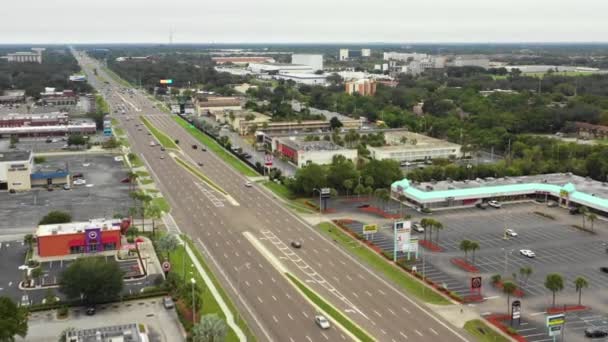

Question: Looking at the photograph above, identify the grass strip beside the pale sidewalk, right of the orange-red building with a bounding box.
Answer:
[169,246,239,342]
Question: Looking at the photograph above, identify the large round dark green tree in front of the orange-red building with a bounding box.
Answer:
[59,257,124,304]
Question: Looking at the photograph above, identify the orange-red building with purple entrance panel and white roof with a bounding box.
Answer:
[36,219,129,258]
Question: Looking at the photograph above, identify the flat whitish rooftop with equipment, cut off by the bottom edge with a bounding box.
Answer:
[66,323,147,342]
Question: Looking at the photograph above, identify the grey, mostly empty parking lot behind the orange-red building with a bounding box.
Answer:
[0,155,132,230]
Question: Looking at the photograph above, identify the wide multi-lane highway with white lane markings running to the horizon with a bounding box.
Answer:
[77,54,468,341]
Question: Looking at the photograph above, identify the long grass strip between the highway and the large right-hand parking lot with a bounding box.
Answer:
[317,222,451,305]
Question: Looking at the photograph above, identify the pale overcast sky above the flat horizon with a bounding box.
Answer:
[0,0,608,44]
